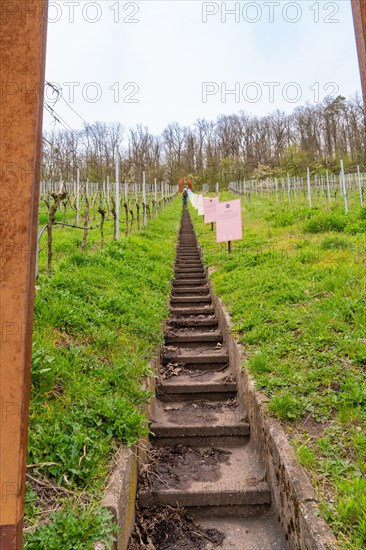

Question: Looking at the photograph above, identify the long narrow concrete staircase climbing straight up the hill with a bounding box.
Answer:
[130,209,289,550]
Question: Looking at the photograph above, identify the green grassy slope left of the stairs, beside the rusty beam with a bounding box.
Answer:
[25,201,180,550]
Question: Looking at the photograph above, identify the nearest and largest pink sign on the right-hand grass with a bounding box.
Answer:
[216,199,243,243]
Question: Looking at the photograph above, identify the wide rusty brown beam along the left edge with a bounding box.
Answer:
[0,0,47,550]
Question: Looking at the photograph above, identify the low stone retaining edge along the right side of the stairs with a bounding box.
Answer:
[213,295,340,550]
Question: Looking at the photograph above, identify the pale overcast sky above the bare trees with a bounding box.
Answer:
[44,0,361,133]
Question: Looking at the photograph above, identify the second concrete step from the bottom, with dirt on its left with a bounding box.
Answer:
[139,444,271,512]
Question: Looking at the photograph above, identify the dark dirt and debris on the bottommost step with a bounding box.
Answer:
[128,506,225,550]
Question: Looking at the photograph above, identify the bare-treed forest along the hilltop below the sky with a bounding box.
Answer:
[42,94,366,186]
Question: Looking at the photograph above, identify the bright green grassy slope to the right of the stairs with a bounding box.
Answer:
[193,194,366,549]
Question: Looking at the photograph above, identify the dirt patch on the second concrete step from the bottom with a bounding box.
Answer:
[140,445,231,491]
